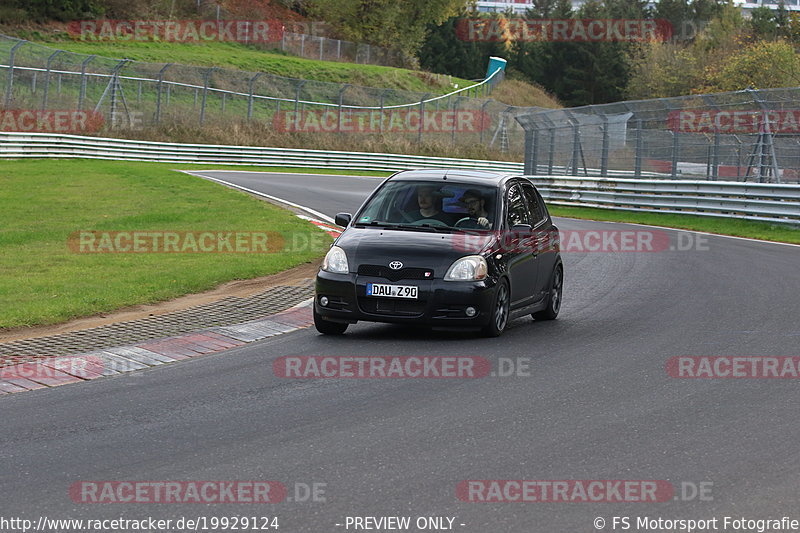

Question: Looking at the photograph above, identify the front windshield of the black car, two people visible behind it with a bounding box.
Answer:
[355,181,497,231]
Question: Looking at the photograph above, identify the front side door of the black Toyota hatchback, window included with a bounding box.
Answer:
[503,181,538,307]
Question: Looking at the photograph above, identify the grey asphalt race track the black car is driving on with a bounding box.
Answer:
[0,172,800,533]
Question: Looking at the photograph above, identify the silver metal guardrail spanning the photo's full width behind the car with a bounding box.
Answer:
[0,132,800,224]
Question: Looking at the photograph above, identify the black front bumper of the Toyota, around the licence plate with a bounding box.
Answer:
[314,271,497,328]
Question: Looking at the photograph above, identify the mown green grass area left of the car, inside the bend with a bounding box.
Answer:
[0,160,330,328]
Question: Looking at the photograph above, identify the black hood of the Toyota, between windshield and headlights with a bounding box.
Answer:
[336,227,491,278]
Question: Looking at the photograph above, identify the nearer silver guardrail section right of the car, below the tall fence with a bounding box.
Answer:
[529,176,800,224]
